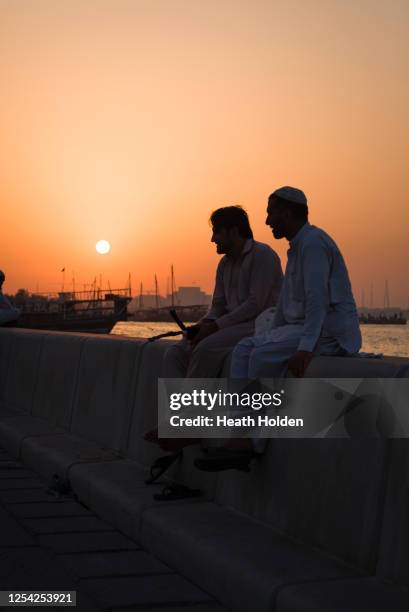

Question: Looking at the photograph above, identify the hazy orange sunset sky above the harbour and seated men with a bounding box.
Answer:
[0,0,409,307]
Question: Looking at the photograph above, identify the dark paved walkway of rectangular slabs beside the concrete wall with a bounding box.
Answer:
[0,448,226,612]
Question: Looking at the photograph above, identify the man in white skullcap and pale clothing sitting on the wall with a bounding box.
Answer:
[231,186,361,378]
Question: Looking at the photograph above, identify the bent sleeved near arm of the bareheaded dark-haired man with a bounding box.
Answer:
[216,250,283,329]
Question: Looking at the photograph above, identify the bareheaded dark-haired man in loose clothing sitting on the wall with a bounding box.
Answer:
[145,206,283,450]
